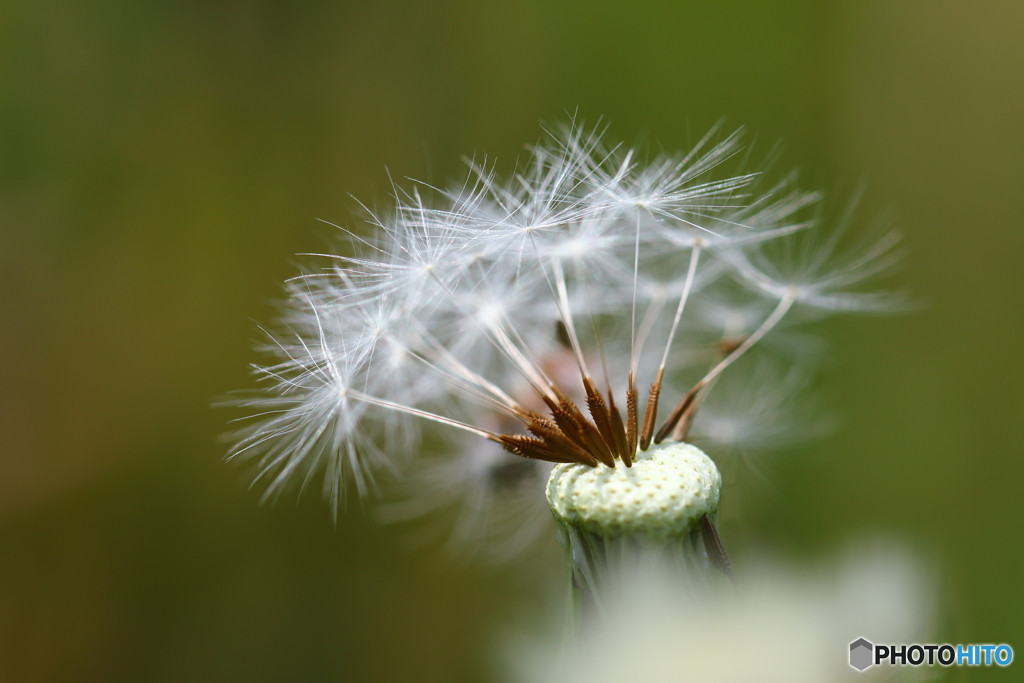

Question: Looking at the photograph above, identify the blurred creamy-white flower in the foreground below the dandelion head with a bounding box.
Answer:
[512,544,936,683]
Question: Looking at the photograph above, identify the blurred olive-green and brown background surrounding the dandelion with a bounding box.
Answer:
[0,0,1024,683]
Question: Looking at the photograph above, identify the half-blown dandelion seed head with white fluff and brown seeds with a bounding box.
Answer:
[230,121,898,582]
